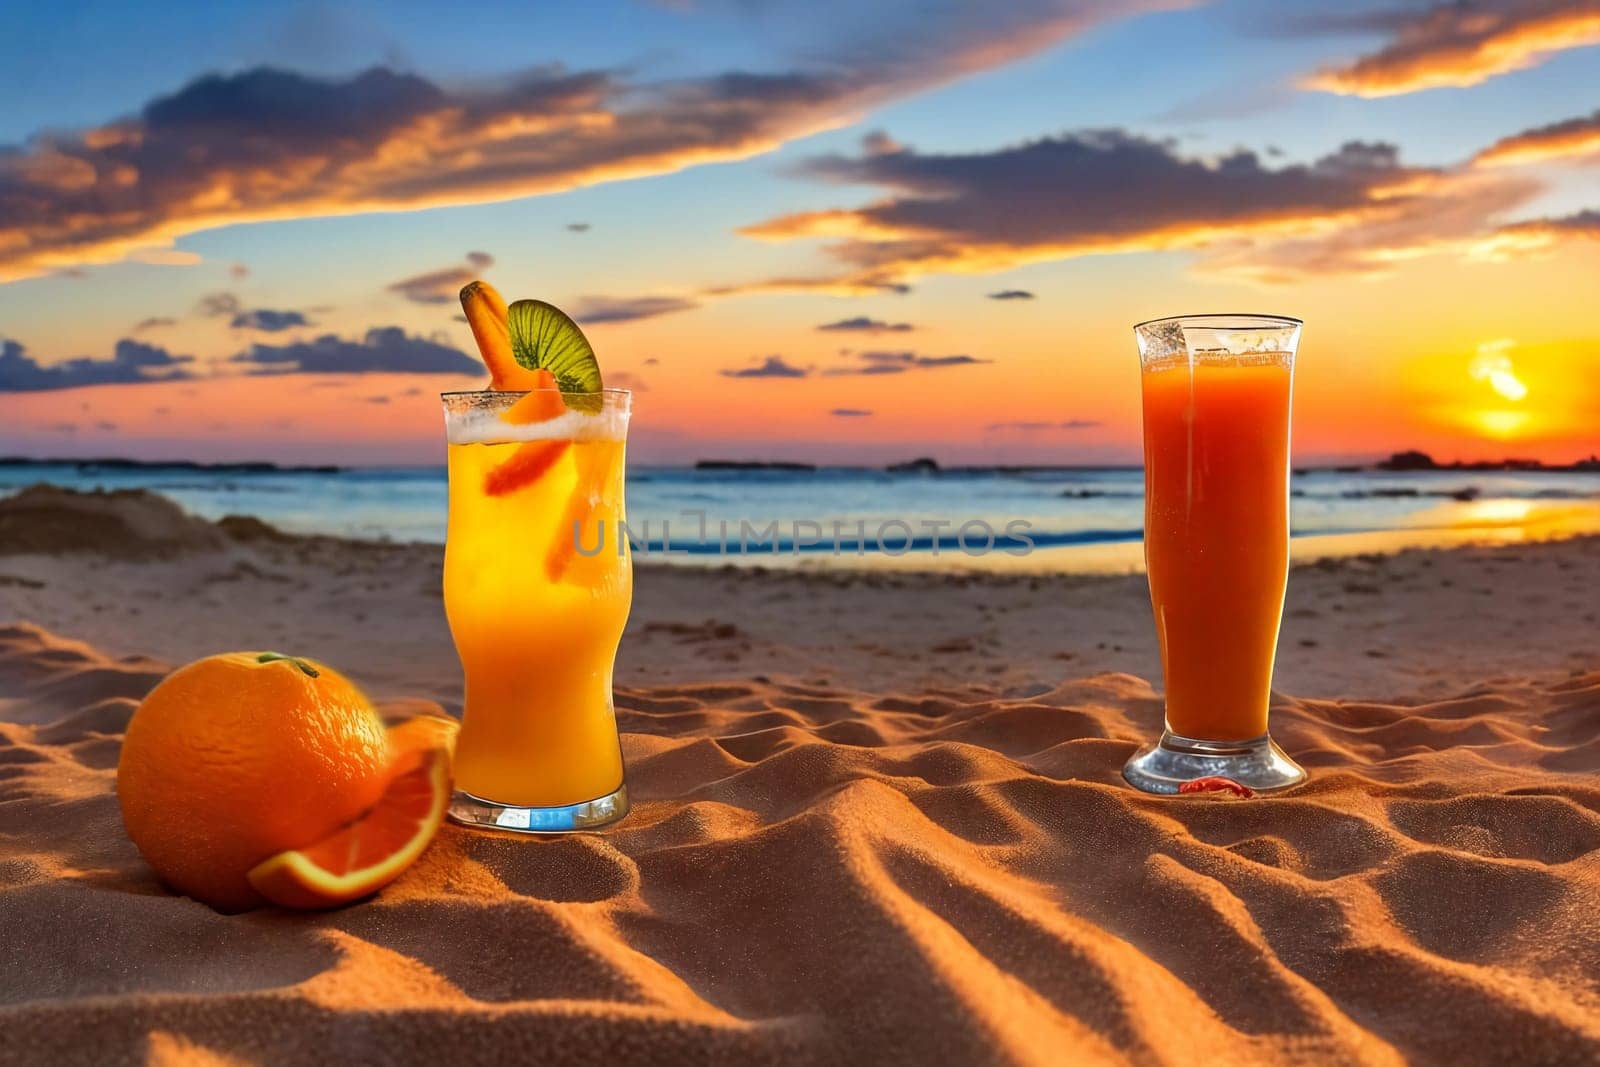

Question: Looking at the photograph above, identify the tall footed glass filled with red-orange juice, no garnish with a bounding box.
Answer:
[1123,315,1306,793]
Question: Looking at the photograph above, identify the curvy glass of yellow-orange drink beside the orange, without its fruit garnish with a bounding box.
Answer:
[443,389,634,833]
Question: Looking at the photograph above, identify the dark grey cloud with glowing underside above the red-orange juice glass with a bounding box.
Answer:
[744,130,1531,283]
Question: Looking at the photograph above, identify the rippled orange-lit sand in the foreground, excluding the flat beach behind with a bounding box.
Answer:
[0,625,1600,1064]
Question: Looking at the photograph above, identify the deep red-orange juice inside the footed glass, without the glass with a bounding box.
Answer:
[1141,354,1293,741]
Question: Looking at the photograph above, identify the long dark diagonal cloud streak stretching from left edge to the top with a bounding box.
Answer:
[0,0,1165,280]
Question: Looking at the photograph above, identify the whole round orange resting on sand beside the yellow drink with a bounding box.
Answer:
[117,653,389,912]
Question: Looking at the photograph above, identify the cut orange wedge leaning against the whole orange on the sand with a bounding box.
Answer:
[250,747,450,909]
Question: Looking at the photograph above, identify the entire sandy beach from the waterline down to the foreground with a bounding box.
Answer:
[0,490,1600,1064]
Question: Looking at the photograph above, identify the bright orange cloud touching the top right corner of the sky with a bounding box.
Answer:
[1306,0,1600,96]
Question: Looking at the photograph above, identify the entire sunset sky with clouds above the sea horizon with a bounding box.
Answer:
[0,0,1600,464]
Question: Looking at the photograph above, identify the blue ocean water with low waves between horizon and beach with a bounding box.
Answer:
[0,464,1600,569]
